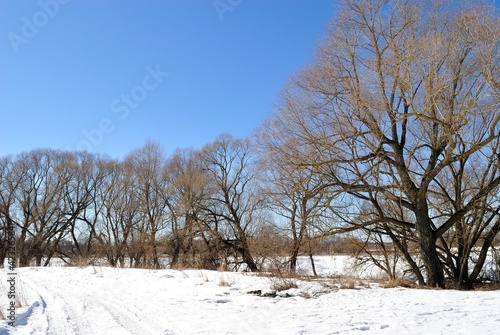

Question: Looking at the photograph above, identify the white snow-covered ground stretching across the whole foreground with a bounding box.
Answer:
[0,258,500,335]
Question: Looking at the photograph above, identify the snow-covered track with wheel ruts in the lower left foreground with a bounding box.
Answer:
[3,269,168,335]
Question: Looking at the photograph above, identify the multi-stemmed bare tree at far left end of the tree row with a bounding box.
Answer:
[5,150,76,266]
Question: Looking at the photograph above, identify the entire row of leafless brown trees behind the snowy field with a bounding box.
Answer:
[0,0,500,287]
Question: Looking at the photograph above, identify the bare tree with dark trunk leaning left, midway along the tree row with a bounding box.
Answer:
[201,133,259,271]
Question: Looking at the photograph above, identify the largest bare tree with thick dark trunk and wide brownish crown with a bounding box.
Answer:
[268,0,500,286]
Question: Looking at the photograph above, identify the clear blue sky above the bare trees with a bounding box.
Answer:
[0,0,335,158]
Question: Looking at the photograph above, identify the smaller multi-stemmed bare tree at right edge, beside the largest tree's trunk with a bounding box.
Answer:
[431,140,500,288]
